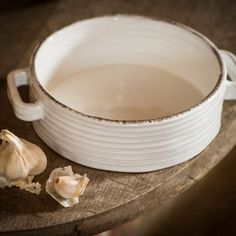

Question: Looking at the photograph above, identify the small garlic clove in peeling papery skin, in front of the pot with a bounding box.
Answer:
[46,166,89,207]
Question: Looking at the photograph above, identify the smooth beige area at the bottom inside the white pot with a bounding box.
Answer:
[47,64,204,120]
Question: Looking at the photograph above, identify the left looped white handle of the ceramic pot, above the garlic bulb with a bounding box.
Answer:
[7,68,43,121]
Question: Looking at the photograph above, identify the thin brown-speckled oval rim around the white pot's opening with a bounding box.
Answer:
[30,14,226,124]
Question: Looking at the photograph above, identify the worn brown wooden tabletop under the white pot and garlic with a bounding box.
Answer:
[0,0,236,235]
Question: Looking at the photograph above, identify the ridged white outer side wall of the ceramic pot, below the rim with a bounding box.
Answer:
[30,68,225,172]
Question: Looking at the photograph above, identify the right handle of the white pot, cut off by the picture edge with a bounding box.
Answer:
[220,50,236,100]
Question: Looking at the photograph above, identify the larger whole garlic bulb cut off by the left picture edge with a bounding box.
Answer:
[0,130,47,193]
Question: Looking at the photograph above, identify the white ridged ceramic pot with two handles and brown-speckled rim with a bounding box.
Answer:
[8,15,236,172]
